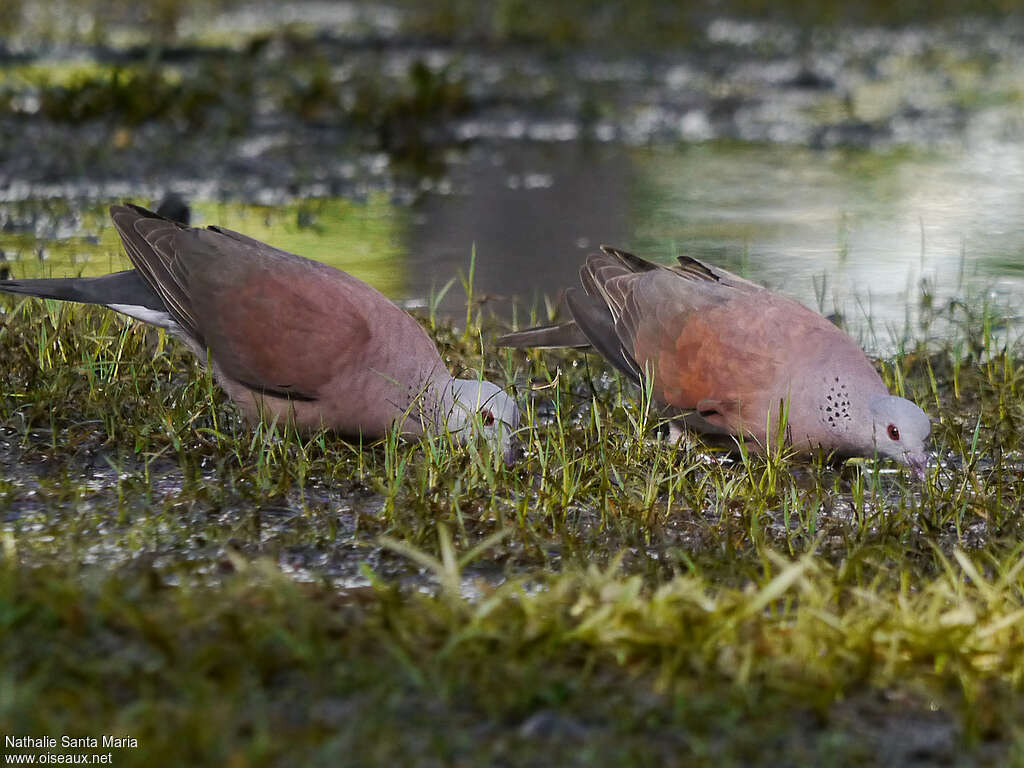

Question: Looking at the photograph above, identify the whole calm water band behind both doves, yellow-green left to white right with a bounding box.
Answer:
[0,141,1024,349]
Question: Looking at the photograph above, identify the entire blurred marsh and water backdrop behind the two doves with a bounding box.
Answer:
[0,0,1024,350]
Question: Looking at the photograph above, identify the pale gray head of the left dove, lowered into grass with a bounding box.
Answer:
[444,379,519,465]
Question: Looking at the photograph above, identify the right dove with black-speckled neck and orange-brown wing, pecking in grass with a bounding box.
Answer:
[498,246,931,477]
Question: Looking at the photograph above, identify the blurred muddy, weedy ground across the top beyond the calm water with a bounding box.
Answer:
[8,0,1024,200]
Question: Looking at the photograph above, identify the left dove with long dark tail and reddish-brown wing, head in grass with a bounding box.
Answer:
[0,205,519,463]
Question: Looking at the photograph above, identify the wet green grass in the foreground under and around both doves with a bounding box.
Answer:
[0,268,1024,765]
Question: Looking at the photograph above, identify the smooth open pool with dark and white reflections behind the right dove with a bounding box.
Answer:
[410,143,1024,347]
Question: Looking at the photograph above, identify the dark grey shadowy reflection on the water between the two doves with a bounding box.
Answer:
[409,142,633,313]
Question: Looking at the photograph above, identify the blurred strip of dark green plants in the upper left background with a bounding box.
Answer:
[0,53,467,148]
